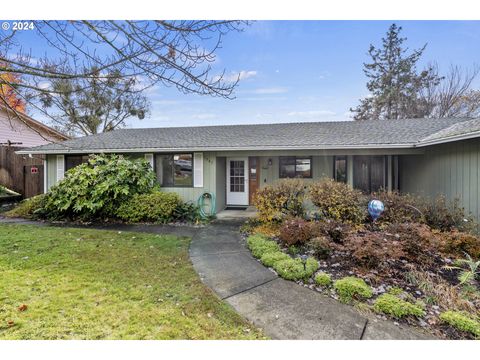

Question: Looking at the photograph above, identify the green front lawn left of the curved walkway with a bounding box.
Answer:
[0,225,263,339]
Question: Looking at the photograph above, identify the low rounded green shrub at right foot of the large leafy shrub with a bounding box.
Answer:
[116,191,181,223]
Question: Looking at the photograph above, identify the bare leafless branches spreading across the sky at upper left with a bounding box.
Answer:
[0,20,245,138]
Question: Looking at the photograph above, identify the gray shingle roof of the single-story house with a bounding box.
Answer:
[16,118,480,153]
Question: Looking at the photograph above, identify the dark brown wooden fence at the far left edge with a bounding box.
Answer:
[0,146,44,198]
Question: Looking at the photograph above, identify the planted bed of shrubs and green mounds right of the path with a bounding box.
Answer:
[242,180,480,339]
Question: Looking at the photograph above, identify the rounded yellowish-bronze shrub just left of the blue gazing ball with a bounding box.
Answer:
[309,178,366,224]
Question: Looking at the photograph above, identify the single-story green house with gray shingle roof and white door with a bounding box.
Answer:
[16,119,480,219]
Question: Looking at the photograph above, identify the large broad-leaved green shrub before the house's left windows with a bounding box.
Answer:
[43,155,158,220]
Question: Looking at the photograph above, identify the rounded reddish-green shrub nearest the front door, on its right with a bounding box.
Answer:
[253,179,306,222]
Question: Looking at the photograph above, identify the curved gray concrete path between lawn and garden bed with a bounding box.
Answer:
[190,222,431,340]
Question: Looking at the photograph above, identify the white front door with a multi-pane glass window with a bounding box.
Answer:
[227,157,248,205]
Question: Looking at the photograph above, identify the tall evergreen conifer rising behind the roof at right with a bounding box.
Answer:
[350,24,440,120]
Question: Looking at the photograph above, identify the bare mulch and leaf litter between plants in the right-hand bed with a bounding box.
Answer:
[244,224,480,339]
